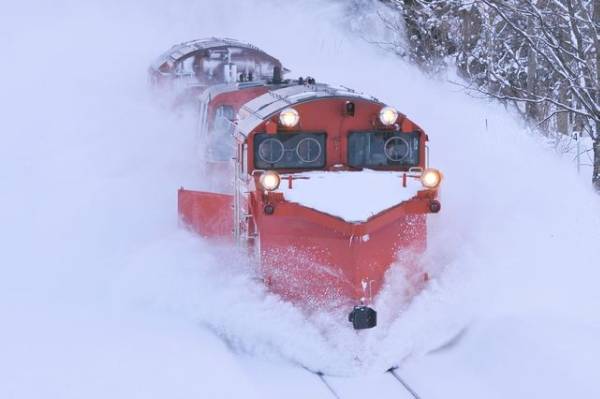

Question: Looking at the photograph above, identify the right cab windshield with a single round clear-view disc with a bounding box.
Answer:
[348,132,419,169]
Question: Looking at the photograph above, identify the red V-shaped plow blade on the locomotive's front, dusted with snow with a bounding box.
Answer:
[251,196,431,307]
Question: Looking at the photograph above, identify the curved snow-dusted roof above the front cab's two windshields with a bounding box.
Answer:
[238,83,381,135]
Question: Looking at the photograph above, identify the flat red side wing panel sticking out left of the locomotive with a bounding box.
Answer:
[177,188,233,240]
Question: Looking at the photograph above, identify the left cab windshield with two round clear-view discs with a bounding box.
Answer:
[254,133,326,169]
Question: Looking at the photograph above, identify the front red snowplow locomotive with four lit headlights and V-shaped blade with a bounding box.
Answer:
[151,39,442,329]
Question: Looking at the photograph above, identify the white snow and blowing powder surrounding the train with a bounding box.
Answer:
[0,0,600,399]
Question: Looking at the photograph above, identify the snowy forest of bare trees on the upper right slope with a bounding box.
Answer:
[381,0,600,189]
